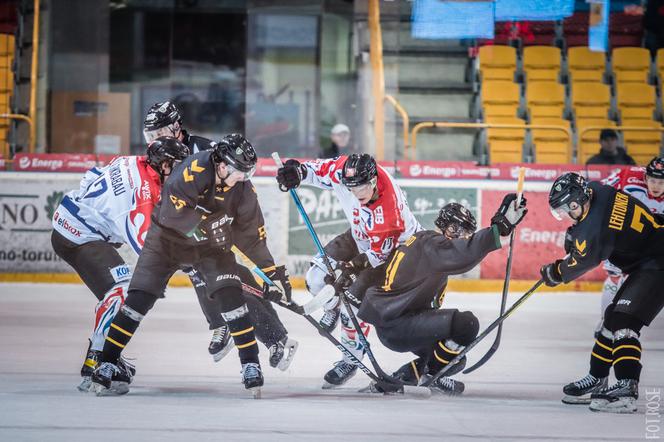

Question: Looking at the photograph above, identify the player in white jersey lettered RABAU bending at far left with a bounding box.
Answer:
[51,137,189,391]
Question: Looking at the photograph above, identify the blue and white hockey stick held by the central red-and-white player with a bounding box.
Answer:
[272,152,430,394]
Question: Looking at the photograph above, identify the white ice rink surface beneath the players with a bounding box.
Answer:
[0,284,664,442]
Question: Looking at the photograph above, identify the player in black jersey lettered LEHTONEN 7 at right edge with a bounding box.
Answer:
[541,173,664,413]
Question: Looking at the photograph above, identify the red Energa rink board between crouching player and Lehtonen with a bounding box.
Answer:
[480,190,606,281]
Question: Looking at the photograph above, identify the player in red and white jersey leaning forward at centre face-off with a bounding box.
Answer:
[277,154,422,388]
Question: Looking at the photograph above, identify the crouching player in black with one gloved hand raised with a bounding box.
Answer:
[358,194,527,395]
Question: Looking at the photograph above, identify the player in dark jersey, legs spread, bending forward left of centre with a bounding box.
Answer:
[91,134,291,395]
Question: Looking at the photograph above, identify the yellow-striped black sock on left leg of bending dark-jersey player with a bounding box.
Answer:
[100,290,157,364]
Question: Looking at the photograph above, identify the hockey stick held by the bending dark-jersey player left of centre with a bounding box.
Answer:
[236,240,431,397]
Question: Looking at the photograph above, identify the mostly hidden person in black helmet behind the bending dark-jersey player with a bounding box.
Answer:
[143,101,298,371]
